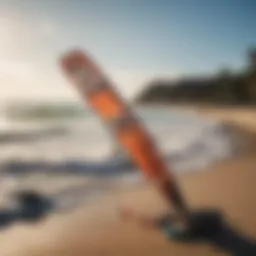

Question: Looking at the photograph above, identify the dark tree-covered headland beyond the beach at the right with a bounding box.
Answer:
[137,49,256,105]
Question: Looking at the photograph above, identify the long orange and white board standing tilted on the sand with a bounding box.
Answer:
[61,50,187,220]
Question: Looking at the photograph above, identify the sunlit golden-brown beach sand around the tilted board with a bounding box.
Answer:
[0,106,256,256]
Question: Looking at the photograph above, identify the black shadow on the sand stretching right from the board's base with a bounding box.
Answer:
[165,211,256,256]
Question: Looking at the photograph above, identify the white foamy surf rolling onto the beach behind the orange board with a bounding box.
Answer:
[0,107,239,209]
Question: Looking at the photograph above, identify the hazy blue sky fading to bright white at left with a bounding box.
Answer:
[0,0,256,101]
